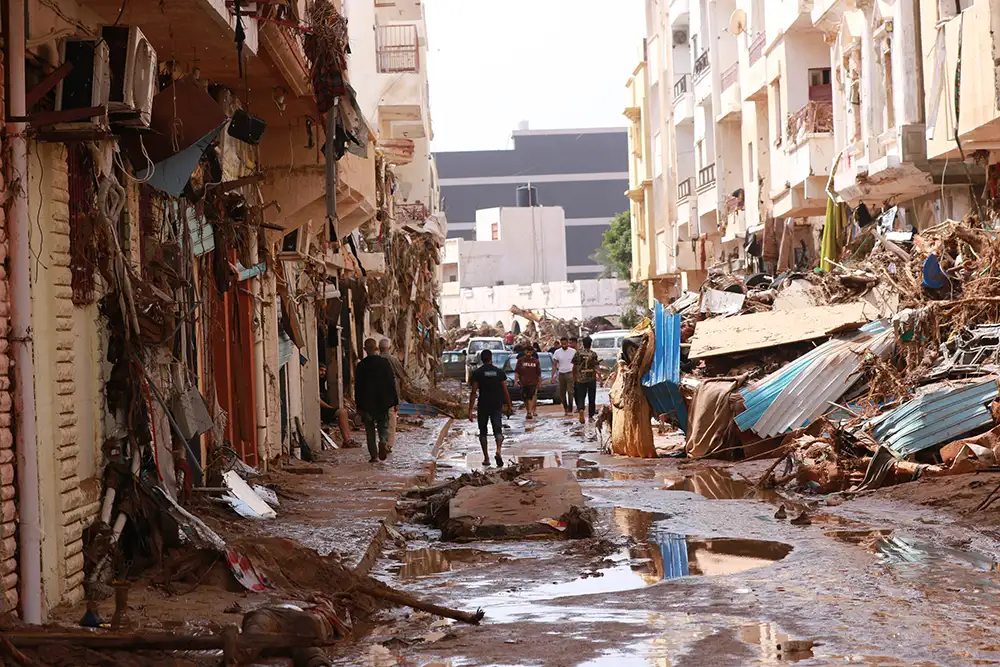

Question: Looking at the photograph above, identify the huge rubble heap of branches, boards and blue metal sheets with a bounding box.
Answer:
[611,214,1000,502]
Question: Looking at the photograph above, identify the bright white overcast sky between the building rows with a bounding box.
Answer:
[424,0,645,151]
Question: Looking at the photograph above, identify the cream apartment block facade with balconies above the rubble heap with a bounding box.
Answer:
[625,0,1000,302]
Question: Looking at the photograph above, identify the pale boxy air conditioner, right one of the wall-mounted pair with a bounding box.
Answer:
[101,25,156,127]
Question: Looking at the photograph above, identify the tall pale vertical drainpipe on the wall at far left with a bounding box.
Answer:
[6,0,42,625]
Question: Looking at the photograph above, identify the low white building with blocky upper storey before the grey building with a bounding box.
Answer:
[441,206,628,329]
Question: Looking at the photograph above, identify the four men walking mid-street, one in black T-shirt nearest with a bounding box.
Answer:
[469,336,600,467]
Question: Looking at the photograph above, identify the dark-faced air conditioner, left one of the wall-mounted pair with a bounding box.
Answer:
[56,37,111,126]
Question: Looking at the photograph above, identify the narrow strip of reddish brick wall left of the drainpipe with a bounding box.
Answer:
[0,53,18,610]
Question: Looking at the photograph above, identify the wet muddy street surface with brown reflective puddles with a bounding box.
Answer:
[337,408,1000,666]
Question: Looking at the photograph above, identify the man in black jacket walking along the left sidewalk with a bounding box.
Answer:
[354,338,399,463]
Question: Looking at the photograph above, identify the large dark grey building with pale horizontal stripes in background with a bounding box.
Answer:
[436,127,628,280]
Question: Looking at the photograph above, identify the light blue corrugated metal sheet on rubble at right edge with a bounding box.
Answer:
[868,378,998,457]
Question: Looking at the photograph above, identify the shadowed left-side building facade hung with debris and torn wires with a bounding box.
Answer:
[0,0,447,623]
